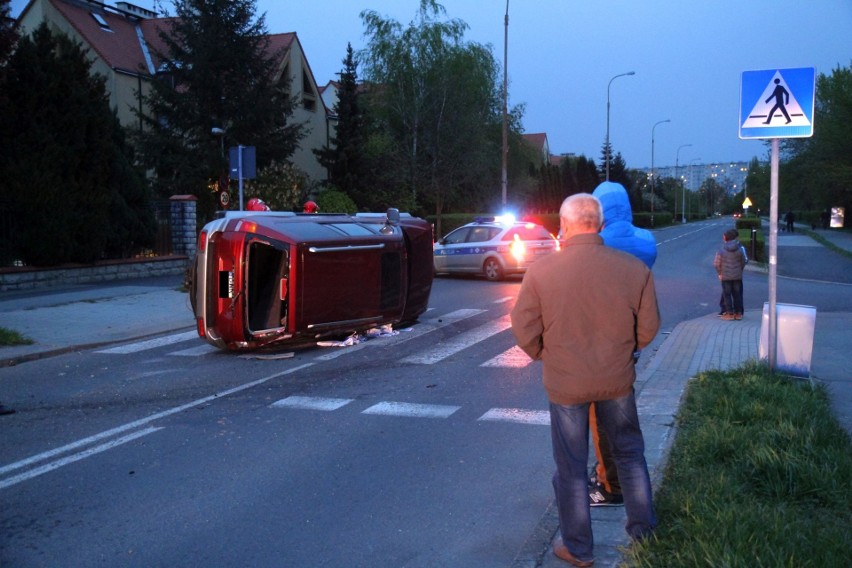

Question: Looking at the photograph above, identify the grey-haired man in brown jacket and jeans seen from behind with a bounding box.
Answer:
[511,193,660,567]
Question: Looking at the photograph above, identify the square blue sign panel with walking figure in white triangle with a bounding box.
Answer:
[740,67,816,140]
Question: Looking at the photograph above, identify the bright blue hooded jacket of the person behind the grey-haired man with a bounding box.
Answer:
[592,181,657,268]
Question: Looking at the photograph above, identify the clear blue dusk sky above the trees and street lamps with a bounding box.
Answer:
[11,0,852,168]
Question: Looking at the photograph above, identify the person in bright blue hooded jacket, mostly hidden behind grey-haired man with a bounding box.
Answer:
[589,181,657,507]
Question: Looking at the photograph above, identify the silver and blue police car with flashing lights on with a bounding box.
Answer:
[433,216,559,280]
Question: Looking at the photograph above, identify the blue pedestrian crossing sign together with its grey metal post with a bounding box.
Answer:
[739,67,816,370]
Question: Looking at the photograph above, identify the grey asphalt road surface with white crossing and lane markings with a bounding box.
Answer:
[0,220,852,567]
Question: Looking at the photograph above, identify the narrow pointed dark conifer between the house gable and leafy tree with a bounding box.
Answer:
[314,43,372,209]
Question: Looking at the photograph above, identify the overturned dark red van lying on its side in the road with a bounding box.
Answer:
[190,209,433,350]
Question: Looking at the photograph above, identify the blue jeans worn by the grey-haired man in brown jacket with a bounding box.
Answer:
[550,392,657,560]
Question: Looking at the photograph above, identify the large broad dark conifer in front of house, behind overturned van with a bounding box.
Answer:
[140,0,302,221]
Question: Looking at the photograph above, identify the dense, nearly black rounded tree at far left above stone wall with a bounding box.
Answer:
[0,24,153,265]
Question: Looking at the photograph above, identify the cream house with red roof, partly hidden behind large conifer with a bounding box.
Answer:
[18,0,329,181]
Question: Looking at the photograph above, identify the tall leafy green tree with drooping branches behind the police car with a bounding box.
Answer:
[361,0,502,217]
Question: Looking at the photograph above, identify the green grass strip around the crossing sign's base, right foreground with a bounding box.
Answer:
[626,362,852,568]
